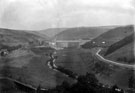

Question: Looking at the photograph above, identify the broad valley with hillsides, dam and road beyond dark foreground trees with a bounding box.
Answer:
[0,26,135,93]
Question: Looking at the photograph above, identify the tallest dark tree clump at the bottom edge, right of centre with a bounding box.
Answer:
[71,73,98,93]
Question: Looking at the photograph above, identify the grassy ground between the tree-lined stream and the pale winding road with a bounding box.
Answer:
[56,49,134,89]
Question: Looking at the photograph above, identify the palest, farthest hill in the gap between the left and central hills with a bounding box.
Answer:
[38,28,67,38]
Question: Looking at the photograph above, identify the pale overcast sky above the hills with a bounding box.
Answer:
[0,0,135,30]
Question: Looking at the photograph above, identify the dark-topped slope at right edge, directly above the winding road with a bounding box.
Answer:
[100,34,135,64]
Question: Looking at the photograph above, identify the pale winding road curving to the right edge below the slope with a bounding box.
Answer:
[95,48,135,70]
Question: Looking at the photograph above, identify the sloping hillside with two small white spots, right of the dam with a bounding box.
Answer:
[82,25,134,48]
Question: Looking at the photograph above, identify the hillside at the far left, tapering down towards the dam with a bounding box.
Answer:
[0,28,46,46]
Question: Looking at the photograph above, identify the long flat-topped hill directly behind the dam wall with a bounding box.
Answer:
[54,27,113,40]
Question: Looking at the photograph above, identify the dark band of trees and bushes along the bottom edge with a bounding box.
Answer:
[4,73,124,93]
